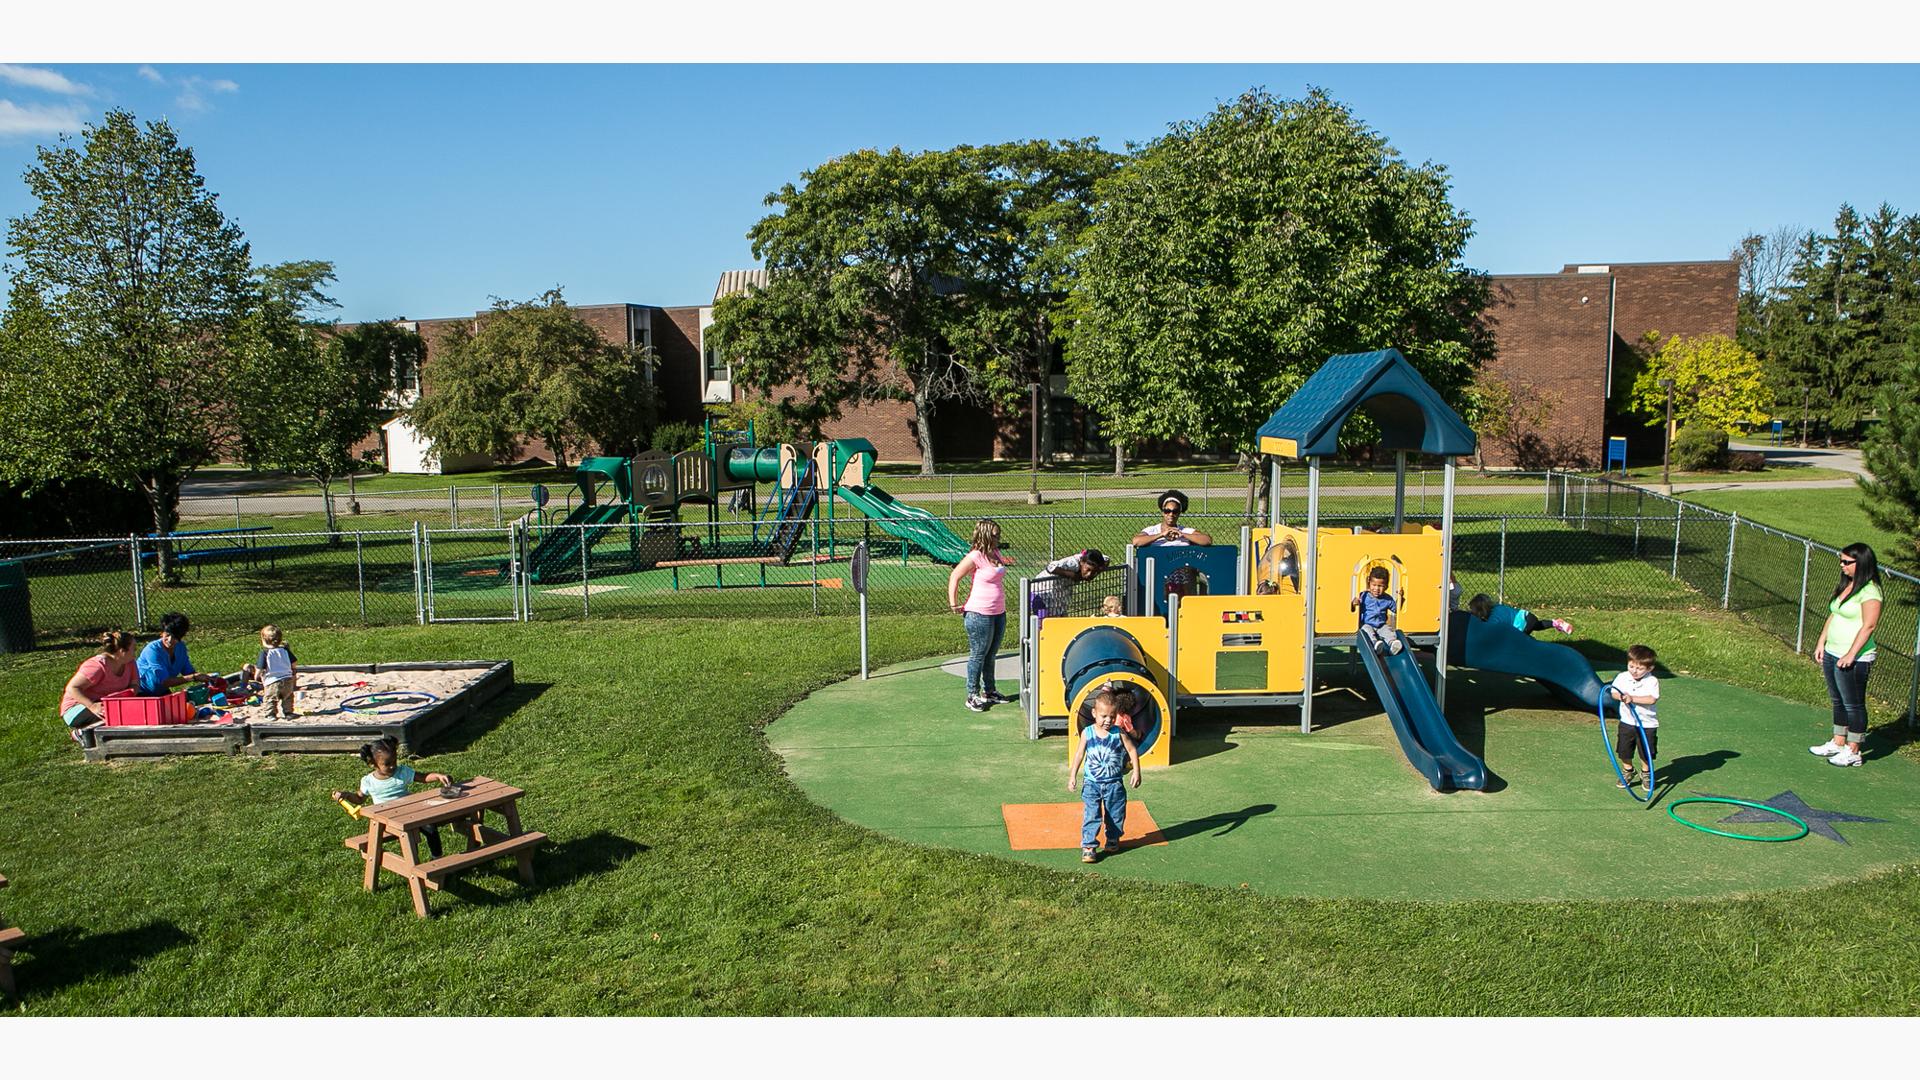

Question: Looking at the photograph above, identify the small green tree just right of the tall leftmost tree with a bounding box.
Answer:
[240,261,424,532]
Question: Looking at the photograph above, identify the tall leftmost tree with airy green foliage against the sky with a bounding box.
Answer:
[0,110,255,571]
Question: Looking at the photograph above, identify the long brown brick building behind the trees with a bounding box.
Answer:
[361,259,1740,471]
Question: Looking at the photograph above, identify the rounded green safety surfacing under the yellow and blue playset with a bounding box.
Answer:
[768,659,1920,901]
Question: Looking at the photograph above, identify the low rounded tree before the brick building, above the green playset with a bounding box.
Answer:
[407,288,659,465]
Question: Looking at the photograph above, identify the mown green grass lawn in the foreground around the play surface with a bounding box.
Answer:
[0,609,1920,1015]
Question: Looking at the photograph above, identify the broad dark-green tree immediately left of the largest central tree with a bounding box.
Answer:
[708,146,1071,473]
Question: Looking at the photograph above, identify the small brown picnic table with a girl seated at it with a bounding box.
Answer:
[346,776,547,919]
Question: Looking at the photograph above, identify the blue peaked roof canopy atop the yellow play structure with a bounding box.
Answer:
[1260,348,1475,457]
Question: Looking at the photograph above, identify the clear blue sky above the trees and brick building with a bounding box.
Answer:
[0,63,1920,319]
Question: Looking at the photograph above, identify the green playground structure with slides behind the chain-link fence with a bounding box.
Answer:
[526,421,968,586]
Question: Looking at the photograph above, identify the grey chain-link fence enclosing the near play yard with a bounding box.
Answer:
[0,488,1920,713]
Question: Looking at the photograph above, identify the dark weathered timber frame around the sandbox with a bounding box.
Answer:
[79,659,513,761]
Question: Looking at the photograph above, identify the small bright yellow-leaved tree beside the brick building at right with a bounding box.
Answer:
[1628,332,1774,434]
